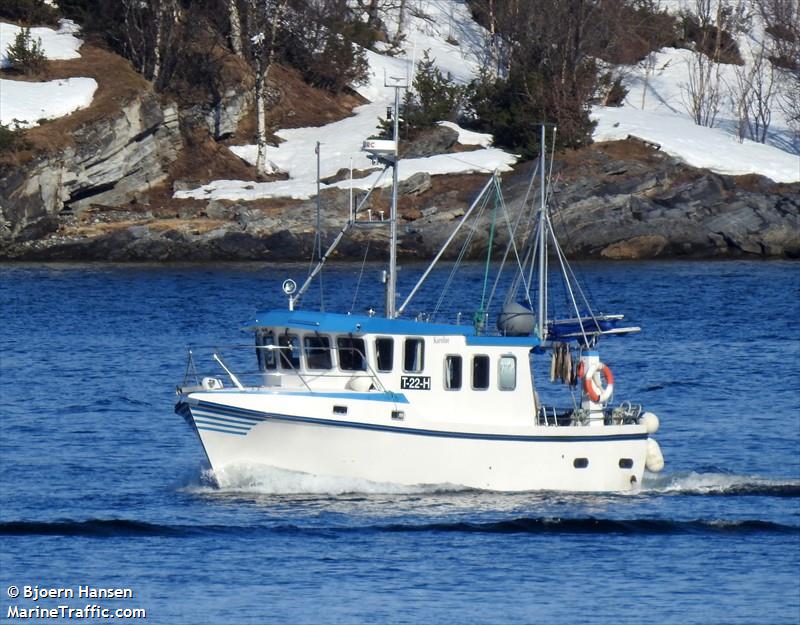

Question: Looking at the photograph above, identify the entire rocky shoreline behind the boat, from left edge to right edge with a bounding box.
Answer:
[0,86,800,261]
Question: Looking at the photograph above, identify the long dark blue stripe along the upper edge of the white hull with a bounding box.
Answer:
[191,401,647,443]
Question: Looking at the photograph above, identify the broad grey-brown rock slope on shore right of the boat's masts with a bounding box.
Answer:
[494,142,800,259]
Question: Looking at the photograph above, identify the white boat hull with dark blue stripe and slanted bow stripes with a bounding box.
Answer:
[182,392,648,492]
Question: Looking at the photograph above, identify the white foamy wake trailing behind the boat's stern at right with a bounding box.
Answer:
[639,471,800,497]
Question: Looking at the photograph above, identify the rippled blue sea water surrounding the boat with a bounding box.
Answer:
[0,262,800,624]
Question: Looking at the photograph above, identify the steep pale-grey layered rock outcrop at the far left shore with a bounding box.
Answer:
[0,92,181,239]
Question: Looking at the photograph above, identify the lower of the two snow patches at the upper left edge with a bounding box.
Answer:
[0,78,97,128]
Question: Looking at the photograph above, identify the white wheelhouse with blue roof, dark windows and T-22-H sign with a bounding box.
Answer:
[245,311,538,418]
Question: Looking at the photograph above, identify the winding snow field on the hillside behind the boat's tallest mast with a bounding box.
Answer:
[175,0,517,200]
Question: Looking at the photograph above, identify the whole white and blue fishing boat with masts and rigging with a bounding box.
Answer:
[176,86,664,492]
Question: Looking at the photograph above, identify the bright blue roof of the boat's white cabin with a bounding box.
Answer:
[243,310,539,347]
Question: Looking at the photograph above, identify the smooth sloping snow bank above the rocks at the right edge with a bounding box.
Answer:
[592,107,800,182]
